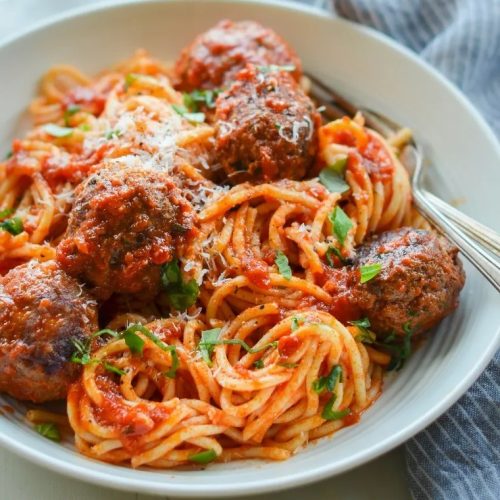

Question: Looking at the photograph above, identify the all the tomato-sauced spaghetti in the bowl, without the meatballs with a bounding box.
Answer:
[0,48,422,468]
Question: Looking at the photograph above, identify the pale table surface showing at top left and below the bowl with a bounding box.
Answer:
[0,0,410,500]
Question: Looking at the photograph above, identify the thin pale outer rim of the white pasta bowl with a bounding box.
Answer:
[0,0,500,497]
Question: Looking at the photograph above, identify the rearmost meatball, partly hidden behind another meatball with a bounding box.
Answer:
[174,20,302,91]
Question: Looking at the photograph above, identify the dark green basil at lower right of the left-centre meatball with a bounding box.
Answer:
[161,259,200,311]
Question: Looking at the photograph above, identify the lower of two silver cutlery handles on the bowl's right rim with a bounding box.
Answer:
[413,190,500,292]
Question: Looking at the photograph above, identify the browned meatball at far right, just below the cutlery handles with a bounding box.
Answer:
[325,227,465,335]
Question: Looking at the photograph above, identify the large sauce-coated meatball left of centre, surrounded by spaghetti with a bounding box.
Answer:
[57,165,194,299]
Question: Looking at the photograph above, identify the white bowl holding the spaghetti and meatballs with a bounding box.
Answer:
[0,0,500,497]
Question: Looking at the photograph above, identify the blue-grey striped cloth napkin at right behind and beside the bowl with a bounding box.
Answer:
[296,0,500,500]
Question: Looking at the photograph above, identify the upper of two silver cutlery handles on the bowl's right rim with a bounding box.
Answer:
[423,190,500,256]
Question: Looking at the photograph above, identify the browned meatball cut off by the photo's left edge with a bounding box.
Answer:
[0,261,98,403]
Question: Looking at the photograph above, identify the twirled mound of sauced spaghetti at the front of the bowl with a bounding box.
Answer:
[68,303,383,468]
